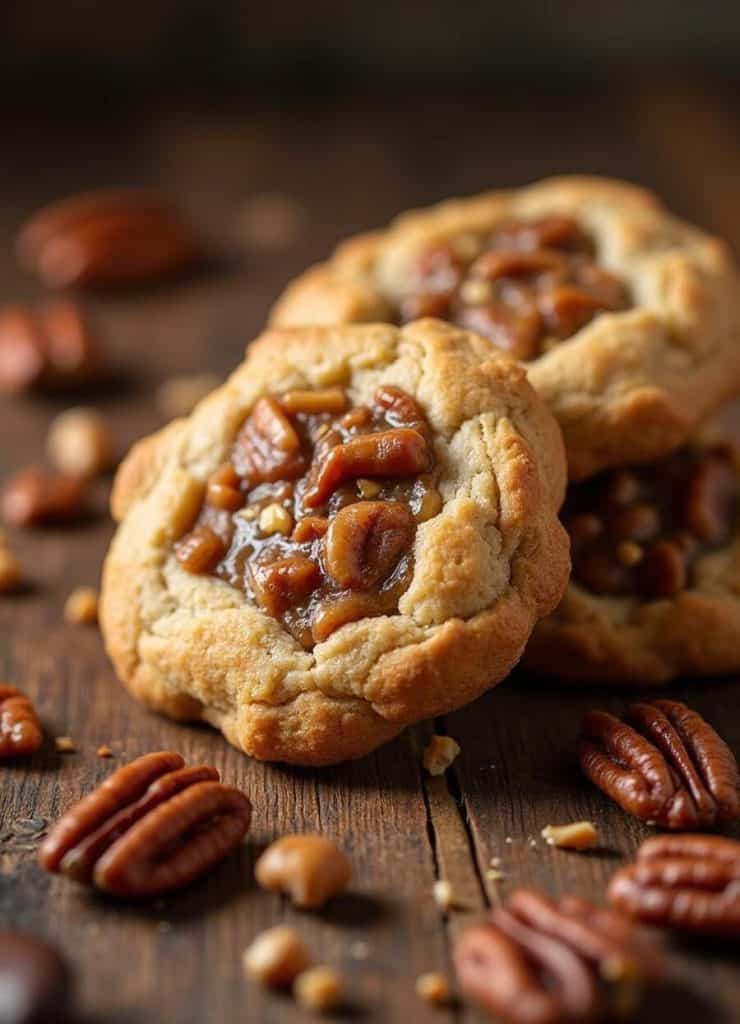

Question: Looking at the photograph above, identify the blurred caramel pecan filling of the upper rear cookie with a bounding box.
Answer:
[399,216,629,360]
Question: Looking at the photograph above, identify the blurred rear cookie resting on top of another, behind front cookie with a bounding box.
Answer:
[272,177,740,479]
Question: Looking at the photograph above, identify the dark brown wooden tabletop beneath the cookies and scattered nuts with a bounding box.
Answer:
[0,82,740,1024]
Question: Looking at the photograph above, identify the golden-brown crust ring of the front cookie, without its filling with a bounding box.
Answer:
[101,321,568,764]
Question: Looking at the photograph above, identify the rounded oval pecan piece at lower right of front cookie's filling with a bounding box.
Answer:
[325,502,415,590]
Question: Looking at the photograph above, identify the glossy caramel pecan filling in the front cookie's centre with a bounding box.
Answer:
[175,386,442,649]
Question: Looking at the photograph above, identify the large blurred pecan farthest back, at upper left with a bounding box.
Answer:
[16,189,199,288]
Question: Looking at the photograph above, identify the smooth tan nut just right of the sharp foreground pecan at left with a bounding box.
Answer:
[255,834,352,909]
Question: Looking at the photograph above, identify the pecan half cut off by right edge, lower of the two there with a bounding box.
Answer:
[609,836,740,938]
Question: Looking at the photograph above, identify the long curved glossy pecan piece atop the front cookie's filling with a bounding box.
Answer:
[304,427,431,508]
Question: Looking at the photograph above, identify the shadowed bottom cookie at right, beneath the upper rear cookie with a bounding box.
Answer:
[523,413,740,684]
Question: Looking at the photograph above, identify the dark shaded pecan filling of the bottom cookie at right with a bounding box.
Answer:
[563,445,738,601]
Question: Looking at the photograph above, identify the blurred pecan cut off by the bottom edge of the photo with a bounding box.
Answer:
[454,889,662,1024]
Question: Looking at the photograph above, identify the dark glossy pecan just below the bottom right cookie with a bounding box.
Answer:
[578,700,740,829]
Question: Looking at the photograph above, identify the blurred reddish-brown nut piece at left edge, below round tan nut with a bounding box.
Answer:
[0,466,87,526]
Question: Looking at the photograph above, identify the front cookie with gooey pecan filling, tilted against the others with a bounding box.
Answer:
[101,321,568,764]
